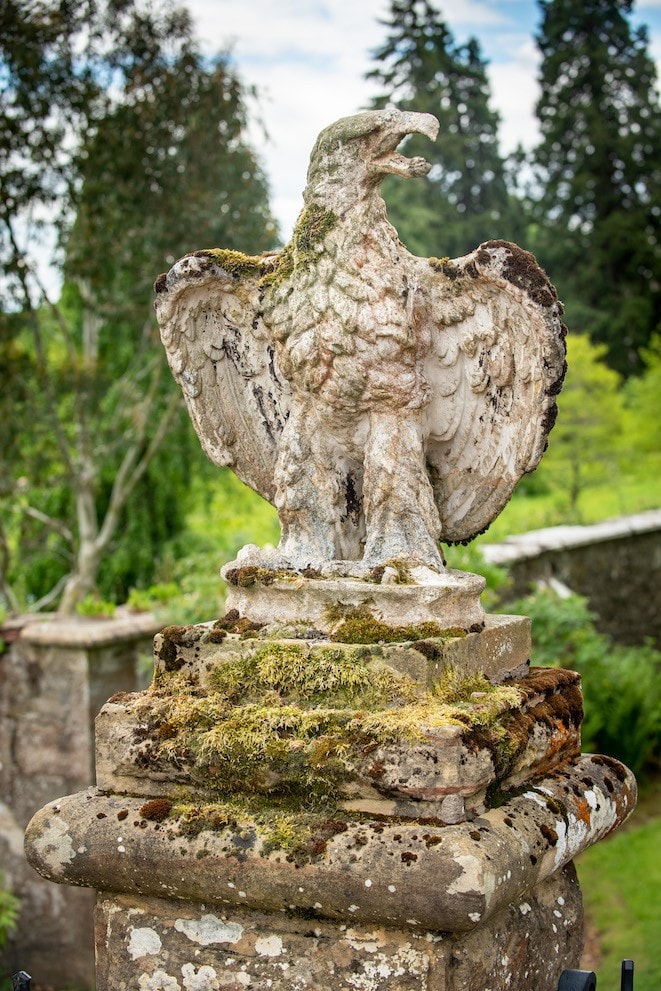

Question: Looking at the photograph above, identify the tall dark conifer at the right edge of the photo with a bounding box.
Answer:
[533,0,661,375]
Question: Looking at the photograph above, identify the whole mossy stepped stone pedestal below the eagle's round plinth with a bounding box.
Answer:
[26,612,635,991]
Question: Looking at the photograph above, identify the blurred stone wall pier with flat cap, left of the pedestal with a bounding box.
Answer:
[0,614,160,988]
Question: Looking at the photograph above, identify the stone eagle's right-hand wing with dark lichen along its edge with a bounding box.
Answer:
[420,241,566,543]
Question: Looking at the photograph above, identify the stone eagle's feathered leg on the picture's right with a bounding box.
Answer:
[363,409,443,571]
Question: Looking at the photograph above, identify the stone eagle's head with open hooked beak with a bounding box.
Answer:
[304,107,439,209]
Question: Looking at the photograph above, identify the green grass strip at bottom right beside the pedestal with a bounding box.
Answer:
[576,780,661,991]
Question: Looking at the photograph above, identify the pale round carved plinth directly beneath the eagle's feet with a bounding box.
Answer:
[223,565,486,632]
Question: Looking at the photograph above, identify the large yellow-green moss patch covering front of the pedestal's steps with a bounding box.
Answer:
[136,642,522,802]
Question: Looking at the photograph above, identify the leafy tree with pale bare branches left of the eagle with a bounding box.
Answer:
[0,0,276,612]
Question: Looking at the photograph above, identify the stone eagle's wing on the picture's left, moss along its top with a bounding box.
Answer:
[154,251,290,502]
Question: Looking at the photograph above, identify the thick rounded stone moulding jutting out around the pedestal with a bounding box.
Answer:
[26,757,636,932]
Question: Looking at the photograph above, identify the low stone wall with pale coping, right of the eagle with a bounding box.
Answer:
[481,509,661,644]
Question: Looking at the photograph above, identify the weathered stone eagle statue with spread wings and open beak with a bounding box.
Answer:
[155,109,566,575]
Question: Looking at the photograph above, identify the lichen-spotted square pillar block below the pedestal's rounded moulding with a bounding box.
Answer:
[96,865,582,991]
